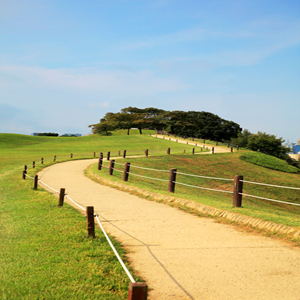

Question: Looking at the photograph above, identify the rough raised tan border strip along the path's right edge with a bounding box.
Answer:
[85,165,300,246]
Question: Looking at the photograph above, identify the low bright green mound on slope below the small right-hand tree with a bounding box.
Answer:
[240,151,300,173]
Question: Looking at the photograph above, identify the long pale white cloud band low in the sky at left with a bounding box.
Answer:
[0,66,190,96]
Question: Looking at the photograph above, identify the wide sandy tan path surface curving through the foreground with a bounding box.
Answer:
[39,159,300,300]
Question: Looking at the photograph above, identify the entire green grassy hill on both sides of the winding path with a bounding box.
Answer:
[0,130,300,300]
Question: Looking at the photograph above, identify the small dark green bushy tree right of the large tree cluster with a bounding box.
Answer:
[247,131,290,159]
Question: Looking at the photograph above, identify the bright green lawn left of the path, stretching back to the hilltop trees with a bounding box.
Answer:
[0,130,199,300]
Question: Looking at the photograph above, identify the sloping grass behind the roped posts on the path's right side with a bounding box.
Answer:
[88,153,300,227]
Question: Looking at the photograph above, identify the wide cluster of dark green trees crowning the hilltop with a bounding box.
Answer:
[89,107,242,142]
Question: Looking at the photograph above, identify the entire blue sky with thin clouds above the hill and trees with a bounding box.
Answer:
[0,0,300,142]
